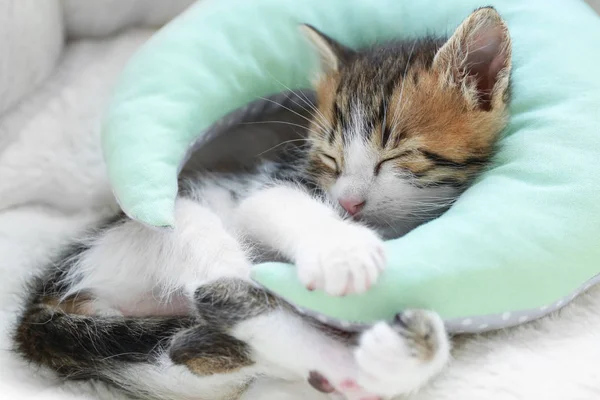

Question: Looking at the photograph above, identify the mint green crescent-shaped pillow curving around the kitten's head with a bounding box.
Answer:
[103,0,600,332]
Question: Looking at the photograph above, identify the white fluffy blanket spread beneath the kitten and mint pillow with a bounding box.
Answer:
[0,3,600,400]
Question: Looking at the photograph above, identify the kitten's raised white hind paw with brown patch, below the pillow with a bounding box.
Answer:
[355,310,450,397]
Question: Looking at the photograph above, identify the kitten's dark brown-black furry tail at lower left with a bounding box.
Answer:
[13,282,193,380]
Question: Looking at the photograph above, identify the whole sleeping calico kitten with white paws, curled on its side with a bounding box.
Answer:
[14,8,511,400]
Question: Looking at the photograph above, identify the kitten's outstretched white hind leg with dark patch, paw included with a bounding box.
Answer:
[190,280,449,400]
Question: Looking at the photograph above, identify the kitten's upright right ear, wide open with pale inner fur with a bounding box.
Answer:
[433,7,511,111]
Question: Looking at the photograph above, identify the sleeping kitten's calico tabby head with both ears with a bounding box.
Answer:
[303,8,511,237]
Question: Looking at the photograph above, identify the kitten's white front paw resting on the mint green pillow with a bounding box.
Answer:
[296,223,386,296]
